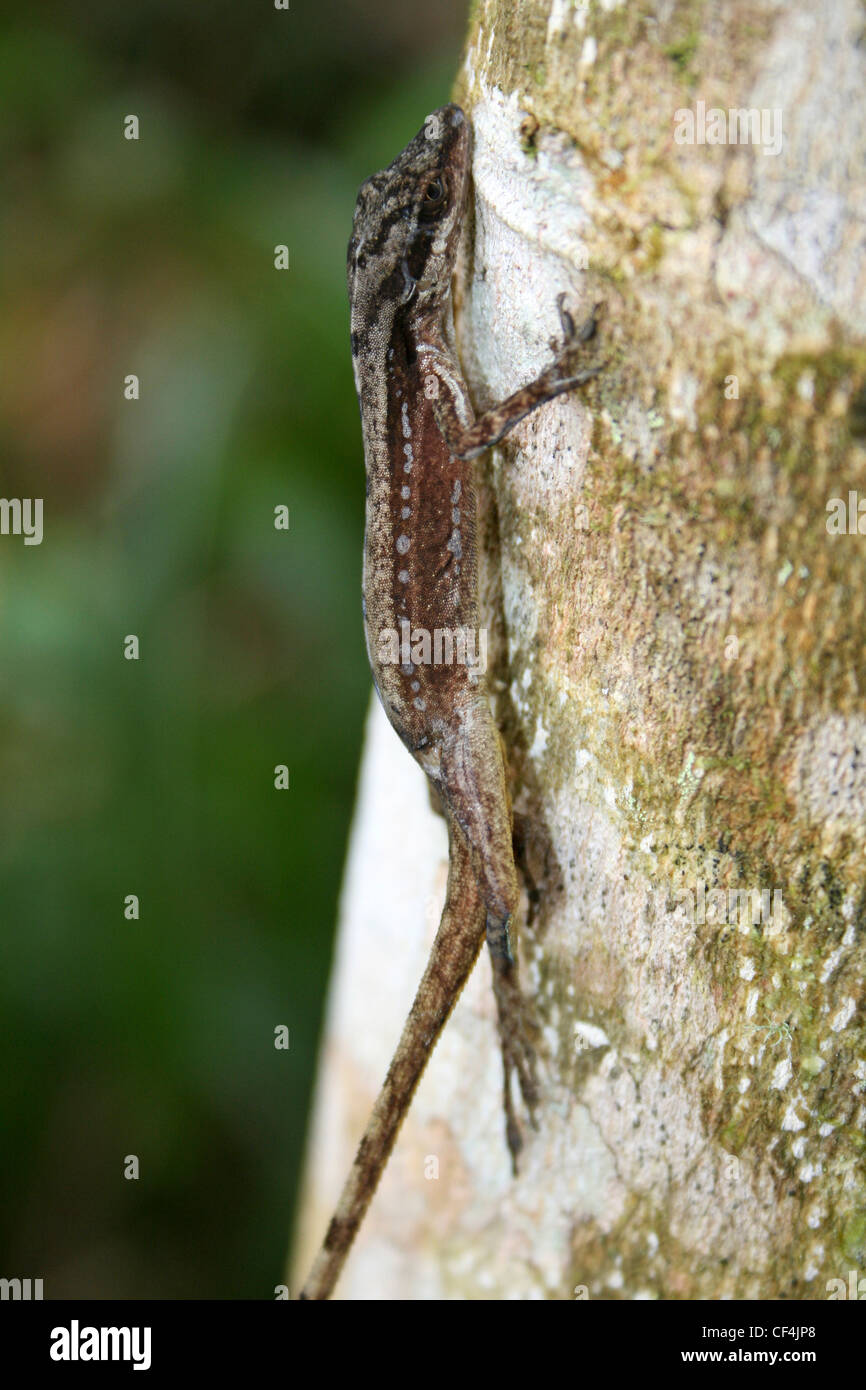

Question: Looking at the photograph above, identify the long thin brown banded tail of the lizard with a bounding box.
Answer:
[299,816,487,1300]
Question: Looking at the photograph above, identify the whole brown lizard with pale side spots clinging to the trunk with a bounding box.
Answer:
[300,106,601,1300]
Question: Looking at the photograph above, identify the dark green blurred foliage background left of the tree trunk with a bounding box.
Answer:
[0,0,466,1298]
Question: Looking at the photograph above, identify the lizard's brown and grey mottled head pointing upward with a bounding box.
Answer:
[349,106,471,331]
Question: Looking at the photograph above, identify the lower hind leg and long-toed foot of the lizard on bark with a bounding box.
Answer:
[487,912,538,1173]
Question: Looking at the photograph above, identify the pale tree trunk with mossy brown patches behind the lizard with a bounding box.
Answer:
[295,0,866,1298]
